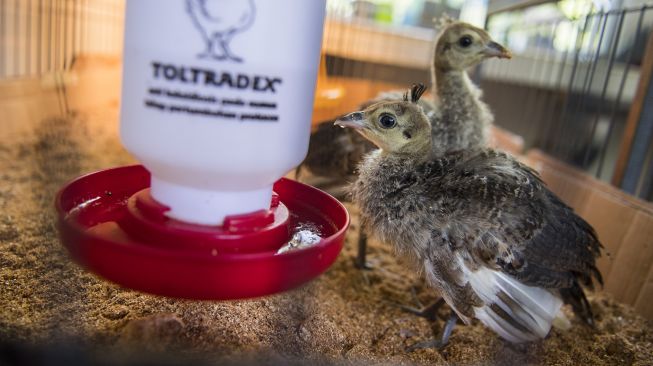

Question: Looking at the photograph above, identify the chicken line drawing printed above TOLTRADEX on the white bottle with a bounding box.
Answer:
[186,0,256,62]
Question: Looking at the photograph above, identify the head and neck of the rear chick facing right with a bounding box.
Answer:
[431,21,512,152]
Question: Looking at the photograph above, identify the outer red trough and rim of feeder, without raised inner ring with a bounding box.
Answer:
[56,165,349,300]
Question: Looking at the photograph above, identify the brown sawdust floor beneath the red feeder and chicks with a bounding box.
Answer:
[0,112,653,365]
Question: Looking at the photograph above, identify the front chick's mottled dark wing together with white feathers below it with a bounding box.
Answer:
[418,150,600,342]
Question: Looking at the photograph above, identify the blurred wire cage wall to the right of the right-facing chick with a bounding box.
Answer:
[480,4,653,200]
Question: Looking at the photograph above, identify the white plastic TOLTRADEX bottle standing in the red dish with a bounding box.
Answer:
[120,0,325,225]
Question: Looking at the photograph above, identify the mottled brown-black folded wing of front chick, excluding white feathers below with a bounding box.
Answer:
[428,150,601,288]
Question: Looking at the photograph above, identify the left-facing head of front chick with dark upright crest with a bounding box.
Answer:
[335,84,431,155]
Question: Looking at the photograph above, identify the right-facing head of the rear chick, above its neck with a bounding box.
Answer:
[434,22,512,70]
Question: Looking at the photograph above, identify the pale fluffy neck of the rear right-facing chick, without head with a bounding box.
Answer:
[433,66,492,151]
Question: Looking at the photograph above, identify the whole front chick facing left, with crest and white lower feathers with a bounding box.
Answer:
[336,87,602,345]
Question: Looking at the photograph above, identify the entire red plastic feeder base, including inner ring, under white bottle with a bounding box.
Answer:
[56,165,349,300]
